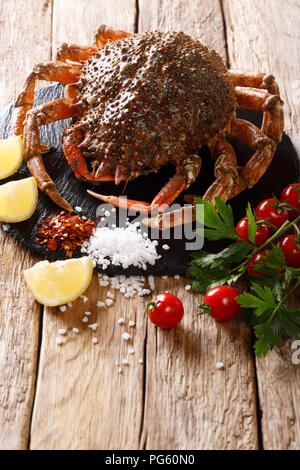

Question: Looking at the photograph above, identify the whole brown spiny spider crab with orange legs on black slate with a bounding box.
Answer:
[11,26,283,228]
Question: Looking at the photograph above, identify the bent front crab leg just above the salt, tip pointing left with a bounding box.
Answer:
[89,155,201,213]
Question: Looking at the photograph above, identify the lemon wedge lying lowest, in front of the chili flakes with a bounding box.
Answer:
[24,256,94,307]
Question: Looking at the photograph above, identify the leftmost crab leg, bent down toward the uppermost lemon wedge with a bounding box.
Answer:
[10,62,81,135]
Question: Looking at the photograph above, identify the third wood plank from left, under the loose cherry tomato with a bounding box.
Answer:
[139,0,258,449]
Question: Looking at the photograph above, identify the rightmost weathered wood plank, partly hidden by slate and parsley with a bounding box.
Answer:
[224,0,300,450]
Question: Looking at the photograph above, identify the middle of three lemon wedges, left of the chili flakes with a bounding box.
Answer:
[0,177,38,223]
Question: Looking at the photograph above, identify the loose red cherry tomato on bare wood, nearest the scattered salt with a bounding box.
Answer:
[146,292,184,328]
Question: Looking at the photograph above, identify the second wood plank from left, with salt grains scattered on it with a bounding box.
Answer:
[31,0,145,449]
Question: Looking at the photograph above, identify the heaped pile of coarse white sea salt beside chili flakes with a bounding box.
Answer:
[81,222,161,270]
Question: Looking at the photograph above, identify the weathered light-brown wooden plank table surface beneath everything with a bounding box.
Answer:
[0,0,300,450]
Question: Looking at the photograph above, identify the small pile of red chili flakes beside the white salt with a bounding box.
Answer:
[37,211,95,258]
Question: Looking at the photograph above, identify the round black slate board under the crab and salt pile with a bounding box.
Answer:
[0,85,299,275]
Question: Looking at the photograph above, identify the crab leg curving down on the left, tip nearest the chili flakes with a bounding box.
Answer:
[24,98,78,211]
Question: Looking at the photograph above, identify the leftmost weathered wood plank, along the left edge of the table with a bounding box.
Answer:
[0,0,51,449]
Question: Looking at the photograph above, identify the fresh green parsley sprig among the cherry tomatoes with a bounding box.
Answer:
[187,198,300,356]
